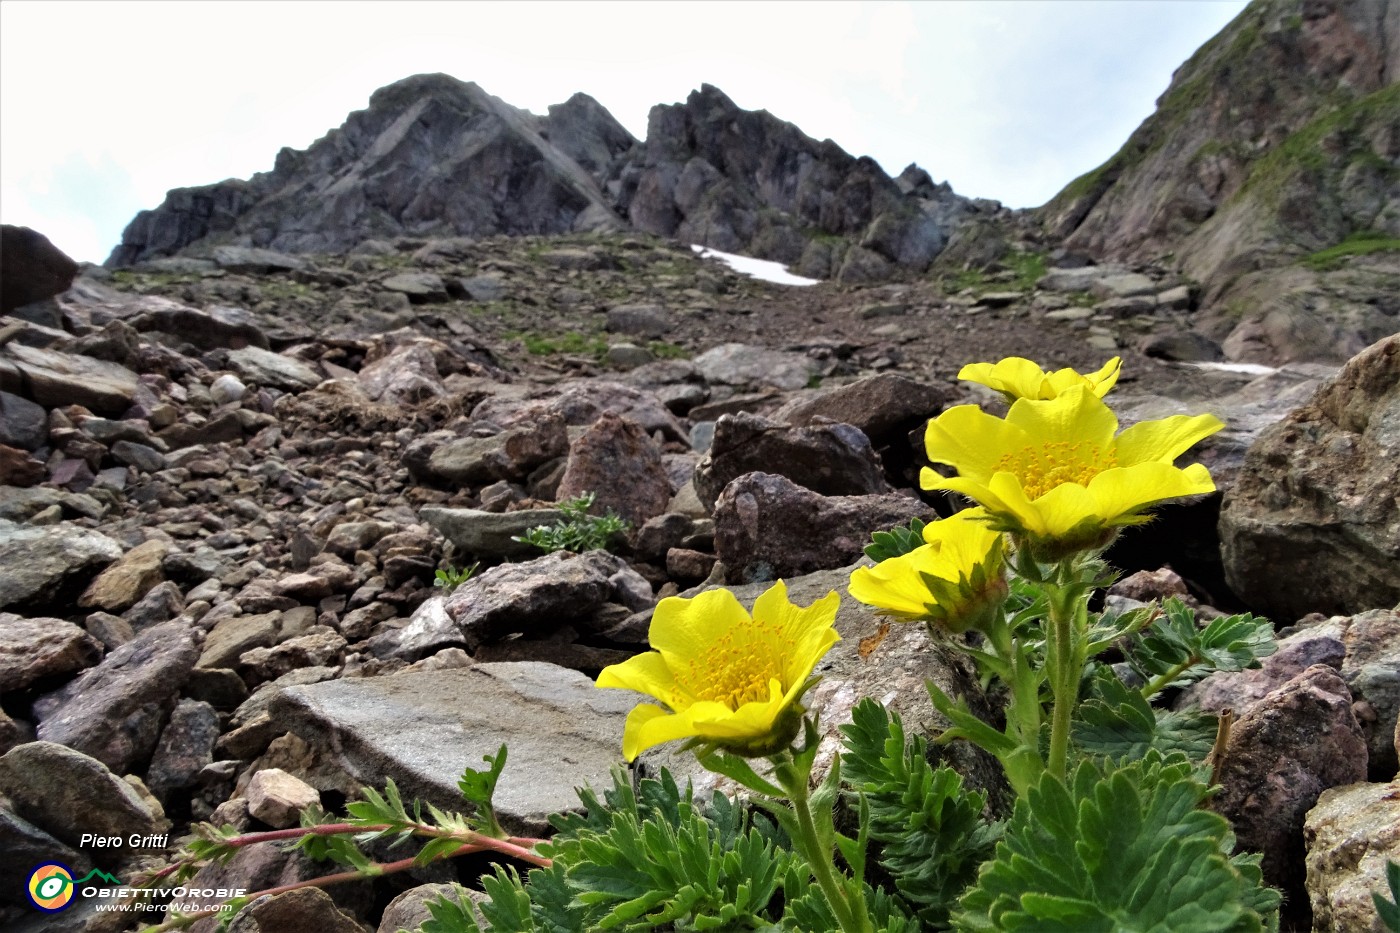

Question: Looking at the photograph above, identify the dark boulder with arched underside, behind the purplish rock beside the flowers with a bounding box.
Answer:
[694,413,892,504]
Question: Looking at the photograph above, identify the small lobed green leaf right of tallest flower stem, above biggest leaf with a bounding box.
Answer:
[1072,667,1215,762]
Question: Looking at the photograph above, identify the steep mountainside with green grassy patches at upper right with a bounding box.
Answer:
[1040,0,1400,361]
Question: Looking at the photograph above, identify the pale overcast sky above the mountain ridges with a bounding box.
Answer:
[0,0,1245,262]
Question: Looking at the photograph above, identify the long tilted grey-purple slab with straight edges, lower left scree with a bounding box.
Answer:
[34,622,199,773]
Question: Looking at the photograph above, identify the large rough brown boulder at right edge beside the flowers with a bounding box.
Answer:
[1219,335,1400,623]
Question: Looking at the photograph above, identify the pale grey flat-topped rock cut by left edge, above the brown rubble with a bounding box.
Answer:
[0,520,122,609]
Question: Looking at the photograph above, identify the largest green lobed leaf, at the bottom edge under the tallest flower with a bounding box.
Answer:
[953,751,1271,933]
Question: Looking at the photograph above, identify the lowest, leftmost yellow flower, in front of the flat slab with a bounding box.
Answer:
[598,580,841,761]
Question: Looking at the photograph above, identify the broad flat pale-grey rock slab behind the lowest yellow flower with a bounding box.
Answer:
[272,661,641,835]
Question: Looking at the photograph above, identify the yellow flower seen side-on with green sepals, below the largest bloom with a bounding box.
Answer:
[850,509,1007,633]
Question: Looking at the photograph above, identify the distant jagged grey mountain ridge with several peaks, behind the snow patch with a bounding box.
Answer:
[108,74,995,280]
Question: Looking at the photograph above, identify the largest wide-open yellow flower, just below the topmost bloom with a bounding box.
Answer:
[920,385,1224,560]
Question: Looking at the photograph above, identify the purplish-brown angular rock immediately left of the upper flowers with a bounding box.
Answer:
[714,474,934,583]
